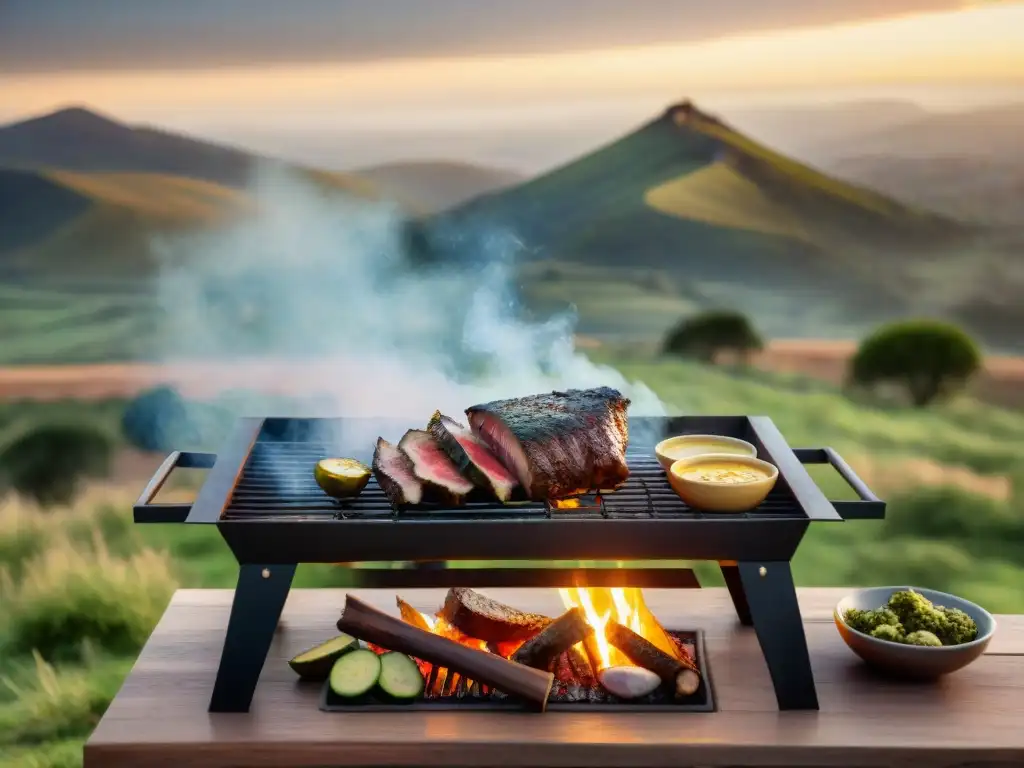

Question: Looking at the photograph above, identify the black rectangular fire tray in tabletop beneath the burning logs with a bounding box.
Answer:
[319,630,716,712]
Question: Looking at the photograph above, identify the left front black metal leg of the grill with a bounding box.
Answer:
[210,564,295,712]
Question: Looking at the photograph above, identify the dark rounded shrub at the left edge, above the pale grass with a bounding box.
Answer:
[0,423,114,507]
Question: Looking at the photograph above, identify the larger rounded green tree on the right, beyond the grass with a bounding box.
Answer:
[849,321,982,408]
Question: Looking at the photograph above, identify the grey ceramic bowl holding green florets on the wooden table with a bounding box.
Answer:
[833,587,995,680]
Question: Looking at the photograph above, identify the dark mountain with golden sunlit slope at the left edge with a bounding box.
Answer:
[0,108,378,275]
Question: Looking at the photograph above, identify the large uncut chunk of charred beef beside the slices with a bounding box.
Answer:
[466,387,630,501]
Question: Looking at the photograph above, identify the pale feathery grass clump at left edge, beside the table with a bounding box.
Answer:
[0,535,176,659]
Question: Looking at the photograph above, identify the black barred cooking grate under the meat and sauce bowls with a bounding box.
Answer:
[221,441,807,521]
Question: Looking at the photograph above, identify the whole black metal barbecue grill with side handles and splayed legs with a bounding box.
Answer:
[134,416,885,712]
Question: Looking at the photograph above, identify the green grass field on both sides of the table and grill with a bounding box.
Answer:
[0,349,1024,768]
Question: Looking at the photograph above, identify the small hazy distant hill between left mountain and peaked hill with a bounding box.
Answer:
[351,161,525,213]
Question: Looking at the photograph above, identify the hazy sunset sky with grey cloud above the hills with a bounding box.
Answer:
[0,0,1024,169]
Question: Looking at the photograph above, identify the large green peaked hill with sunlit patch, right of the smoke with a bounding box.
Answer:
[426,102,969,335]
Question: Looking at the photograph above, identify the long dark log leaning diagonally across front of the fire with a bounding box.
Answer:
[338,595,554,712]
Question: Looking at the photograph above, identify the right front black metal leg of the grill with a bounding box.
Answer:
[730,562,818,710]
